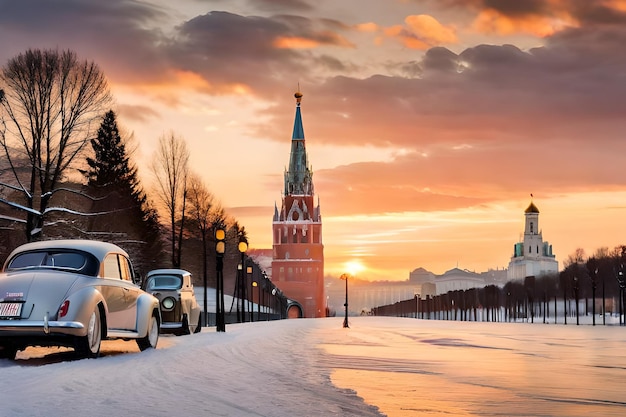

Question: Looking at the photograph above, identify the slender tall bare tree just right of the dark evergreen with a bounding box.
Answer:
[151,132,189,268]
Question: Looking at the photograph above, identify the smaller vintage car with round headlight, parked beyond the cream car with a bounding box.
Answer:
[142,269,202,336]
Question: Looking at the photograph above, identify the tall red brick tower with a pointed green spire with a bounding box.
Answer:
[272,91,326,318]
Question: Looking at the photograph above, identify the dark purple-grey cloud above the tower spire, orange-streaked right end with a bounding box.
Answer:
[166,12,349,97]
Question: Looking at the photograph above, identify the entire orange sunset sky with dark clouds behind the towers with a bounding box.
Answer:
[0,0,626,280]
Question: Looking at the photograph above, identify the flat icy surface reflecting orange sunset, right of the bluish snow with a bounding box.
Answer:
[323,318,626,417]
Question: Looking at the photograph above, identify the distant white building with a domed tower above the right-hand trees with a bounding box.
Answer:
[507,201,559,281]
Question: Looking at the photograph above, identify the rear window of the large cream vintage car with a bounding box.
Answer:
[7,250,99,276]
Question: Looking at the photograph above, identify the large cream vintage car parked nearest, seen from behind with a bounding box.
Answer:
[0,240,161,359]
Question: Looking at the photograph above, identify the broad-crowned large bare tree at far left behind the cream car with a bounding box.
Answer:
[0,49,111,241]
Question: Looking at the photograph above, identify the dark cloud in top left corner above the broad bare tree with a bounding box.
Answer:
[0,0,166,82]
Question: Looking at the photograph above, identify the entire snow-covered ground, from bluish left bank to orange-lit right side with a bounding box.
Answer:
[0,317,626,417]
